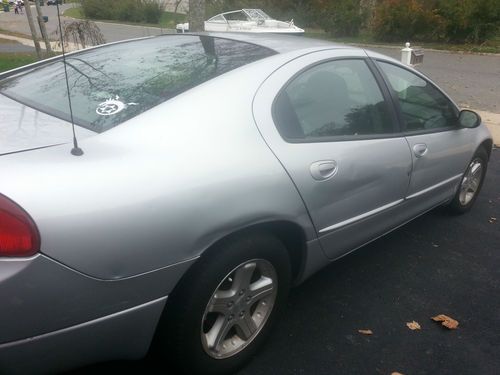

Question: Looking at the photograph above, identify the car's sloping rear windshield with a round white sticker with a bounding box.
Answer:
[0,35,275,133]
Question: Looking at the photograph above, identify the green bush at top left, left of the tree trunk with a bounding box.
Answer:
[81,0,163,23]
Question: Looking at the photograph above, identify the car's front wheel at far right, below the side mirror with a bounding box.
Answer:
[448,147,488,215]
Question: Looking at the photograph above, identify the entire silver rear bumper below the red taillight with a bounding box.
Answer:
[0,254,195,374]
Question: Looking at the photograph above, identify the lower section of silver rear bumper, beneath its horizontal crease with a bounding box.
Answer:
[0,297,167,374]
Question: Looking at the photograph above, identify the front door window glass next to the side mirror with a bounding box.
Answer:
[378,62,458,131]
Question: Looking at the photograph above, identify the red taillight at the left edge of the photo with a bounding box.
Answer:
[0,194,40,257]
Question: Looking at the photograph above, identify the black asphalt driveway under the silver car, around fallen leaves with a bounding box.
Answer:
[68,149,500,375]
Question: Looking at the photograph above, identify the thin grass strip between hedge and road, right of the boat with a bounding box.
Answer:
[305,29,500,53]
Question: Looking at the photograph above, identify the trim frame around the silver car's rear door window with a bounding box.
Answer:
[271,56,402,144]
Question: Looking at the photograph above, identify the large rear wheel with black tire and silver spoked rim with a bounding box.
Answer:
[155,233,291,375]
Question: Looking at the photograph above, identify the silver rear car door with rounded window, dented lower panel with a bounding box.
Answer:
[253,49,412,258]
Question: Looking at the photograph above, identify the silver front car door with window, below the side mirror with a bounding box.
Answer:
[377,60,474,209]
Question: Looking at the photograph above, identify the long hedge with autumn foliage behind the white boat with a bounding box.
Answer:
[208,0,500,44]
